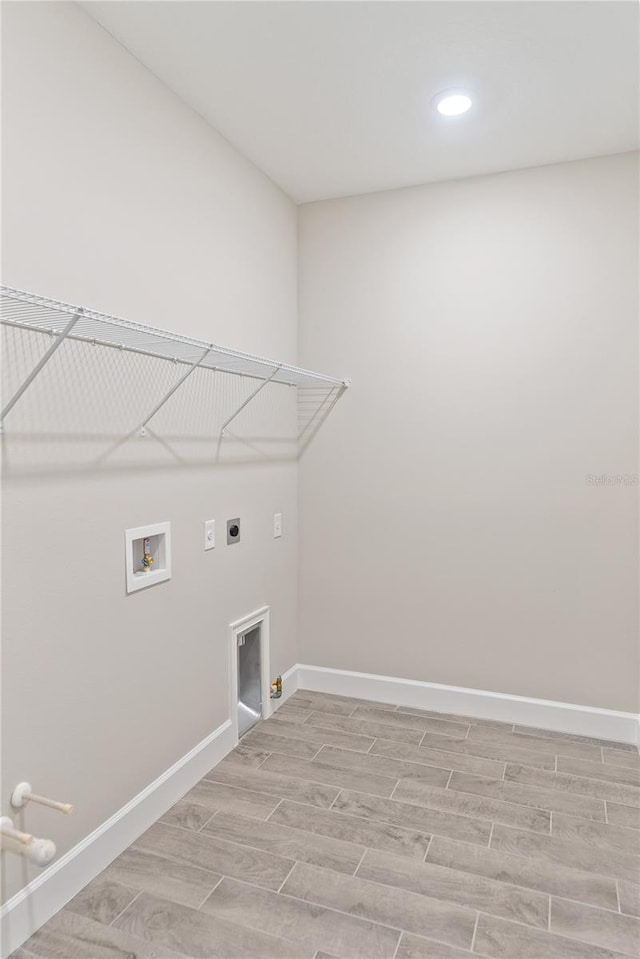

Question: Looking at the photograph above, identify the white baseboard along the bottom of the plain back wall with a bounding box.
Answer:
[289,664,640,744]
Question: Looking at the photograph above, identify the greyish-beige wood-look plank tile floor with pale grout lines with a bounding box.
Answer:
[14,690,640,959]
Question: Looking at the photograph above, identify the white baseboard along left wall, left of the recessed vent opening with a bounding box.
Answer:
[0,716,235,959]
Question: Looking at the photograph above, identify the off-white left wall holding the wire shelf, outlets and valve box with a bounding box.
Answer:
[1,3,297,895]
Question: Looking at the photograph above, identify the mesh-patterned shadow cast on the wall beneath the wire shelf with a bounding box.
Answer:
[2,327,342,477]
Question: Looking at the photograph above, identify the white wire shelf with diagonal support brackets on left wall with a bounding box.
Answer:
[0,286,349,433]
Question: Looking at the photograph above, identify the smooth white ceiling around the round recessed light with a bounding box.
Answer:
[82,0,640,203]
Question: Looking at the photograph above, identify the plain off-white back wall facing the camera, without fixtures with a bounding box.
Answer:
[300,155,638,711]
